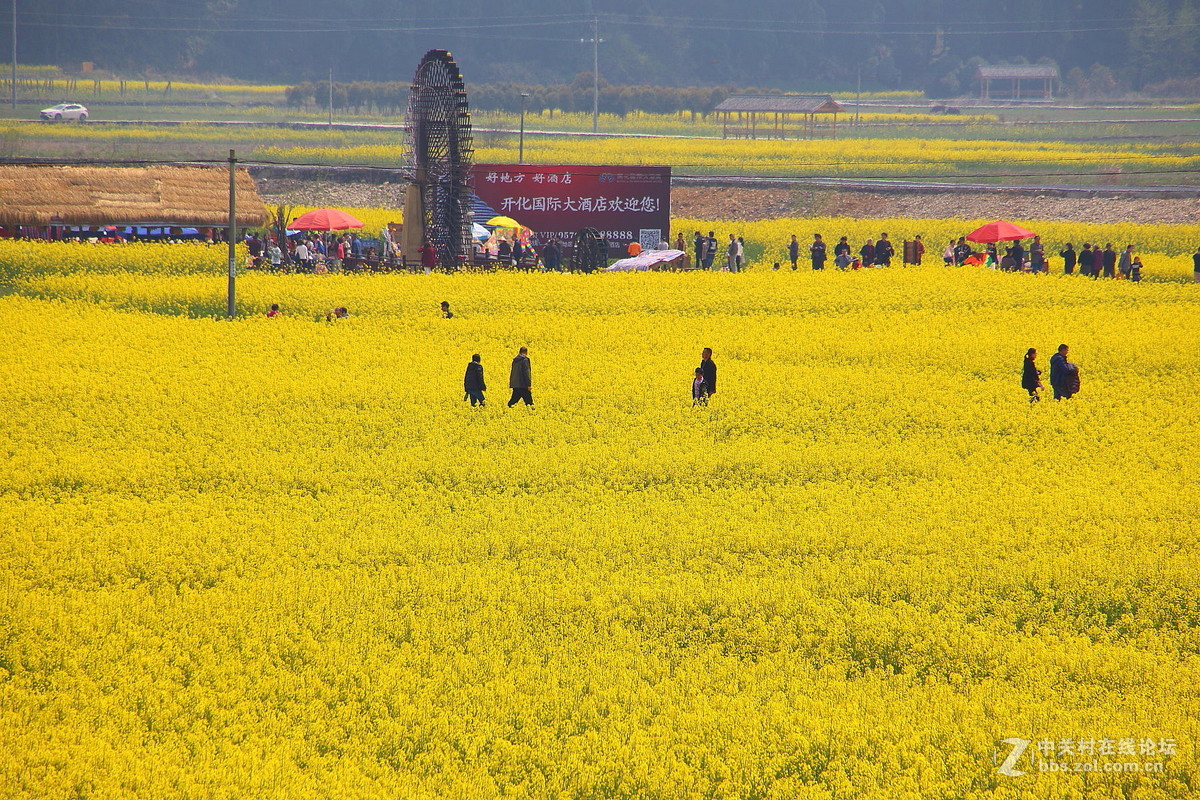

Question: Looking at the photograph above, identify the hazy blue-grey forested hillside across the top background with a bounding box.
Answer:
[9,0,1200,97]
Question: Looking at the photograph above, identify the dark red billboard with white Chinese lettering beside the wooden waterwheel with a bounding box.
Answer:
[473,164,671,254]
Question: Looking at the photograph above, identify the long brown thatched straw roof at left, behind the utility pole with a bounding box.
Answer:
[0,166,269,228]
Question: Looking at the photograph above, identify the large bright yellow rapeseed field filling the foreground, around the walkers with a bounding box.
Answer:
[0,239,1200,800]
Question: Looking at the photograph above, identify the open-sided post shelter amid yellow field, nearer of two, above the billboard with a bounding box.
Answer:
[713,95,846,139]
